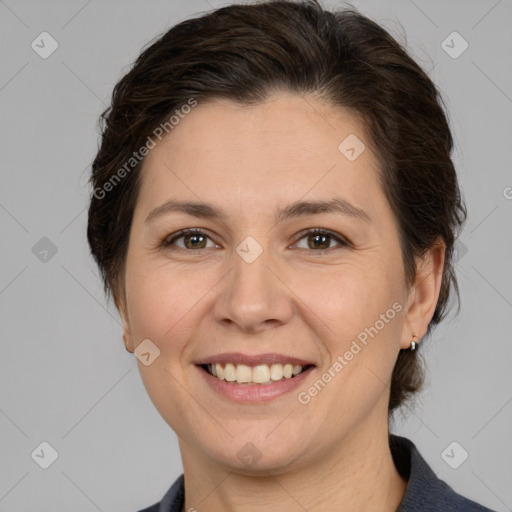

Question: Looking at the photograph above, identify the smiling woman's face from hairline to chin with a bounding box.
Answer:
[123,93,429,472]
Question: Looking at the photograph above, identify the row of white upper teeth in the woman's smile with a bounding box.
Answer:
[208,363,304,384]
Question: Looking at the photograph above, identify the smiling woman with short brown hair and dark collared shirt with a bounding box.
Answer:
[88,1,496,512]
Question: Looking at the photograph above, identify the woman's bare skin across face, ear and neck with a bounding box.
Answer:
[117,92,444,512]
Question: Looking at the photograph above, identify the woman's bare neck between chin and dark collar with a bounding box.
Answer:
[180,408,407,512]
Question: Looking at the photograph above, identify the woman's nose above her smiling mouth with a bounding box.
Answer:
[214,242,293,333]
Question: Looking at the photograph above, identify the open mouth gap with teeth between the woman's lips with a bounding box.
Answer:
[198,362,315,386]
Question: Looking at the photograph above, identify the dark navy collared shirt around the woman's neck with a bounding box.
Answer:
[136,434,495,512]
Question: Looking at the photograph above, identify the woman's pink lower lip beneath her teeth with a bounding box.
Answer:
[197,366,315,403]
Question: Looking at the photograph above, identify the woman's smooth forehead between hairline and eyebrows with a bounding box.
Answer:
[139,93,383,226]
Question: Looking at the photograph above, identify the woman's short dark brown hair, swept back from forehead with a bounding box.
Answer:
[87,0,466,415]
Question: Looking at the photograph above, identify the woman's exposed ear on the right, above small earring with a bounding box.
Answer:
[400,238,446,349]
